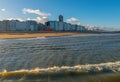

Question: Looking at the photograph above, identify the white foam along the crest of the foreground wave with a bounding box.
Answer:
[0,61,120,74]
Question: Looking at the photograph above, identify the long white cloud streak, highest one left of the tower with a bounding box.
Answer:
[22,8,51,17]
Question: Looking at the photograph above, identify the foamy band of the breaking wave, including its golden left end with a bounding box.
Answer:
[0,61,120,77]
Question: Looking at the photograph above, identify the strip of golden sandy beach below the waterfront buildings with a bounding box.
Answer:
[0,32,86,39]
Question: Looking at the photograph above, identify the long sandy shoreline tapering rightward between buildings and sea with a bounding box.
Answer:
[0,32,118,39]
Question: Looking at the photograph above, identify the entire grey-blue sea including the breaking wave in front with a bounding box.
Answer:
[0,33,120,82]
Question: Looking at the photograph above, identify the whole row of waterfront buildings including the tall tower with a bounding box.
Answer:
[0,15,87,32]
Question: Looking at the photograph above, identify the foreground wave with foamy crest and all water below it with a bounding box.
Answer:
[0,61,120,82]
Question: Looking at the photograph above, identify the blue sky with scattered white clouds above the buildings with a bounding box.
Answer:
[0,0,120,30]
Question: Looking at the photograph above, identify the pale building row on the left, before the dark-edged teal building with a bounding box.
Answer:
[0,20,46,32]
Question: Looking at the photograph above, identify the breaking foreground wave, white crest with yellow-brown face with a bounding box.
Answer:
[0,61,120,82]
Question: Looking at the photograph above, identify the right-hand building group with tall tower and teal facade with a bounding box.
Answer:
[45,15,87,32]
